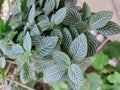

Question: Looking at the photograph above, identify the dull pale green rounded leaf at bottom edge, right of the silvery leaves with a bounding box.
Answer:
[86,73,103,90]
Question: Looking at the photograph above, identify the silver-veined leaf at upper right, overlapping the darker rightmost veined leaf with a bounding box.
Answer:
[89,11,113,29]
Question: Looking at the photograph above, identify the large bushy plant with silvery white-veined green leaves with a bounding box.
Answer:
[0,0,120,90]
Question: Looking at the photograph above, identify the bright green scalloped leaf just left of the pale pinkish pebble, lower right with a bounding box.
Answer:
[92,53,109,70]
